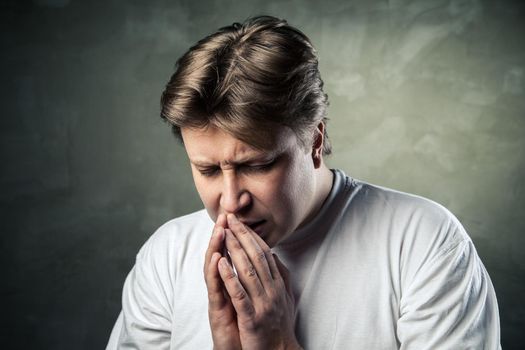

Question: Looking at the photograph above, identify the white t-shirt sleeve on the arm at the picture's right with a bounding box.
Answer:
[397,227,501,350]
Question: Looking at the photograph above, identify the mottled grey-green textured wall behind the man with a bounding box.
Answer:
[0,0,525,349]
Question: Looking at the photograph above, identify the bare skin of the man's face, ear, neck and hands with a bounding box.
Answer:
[182,123,332,349]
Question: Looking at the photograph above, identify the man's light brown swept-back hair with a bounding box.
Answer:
[161,16,331,155]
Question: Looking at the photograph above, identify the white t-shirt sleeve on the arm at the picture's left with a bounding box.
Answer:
[106,234,171,350]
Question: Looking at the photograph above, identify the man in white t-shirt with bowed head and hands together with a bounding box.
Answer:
[108,17,499,350]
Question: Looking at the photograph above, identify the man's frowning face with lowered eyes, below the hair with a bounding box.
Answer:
[181,126,315,247]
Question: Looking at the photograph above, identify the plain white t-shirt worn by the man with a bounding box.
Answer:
[107,170,500,350]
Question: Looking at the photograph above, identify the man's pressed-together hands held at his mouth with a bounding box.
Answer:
[204,214,301,350]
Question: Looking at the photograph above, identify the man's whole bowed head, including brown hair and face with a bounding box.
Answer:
[161,17,331,246]
